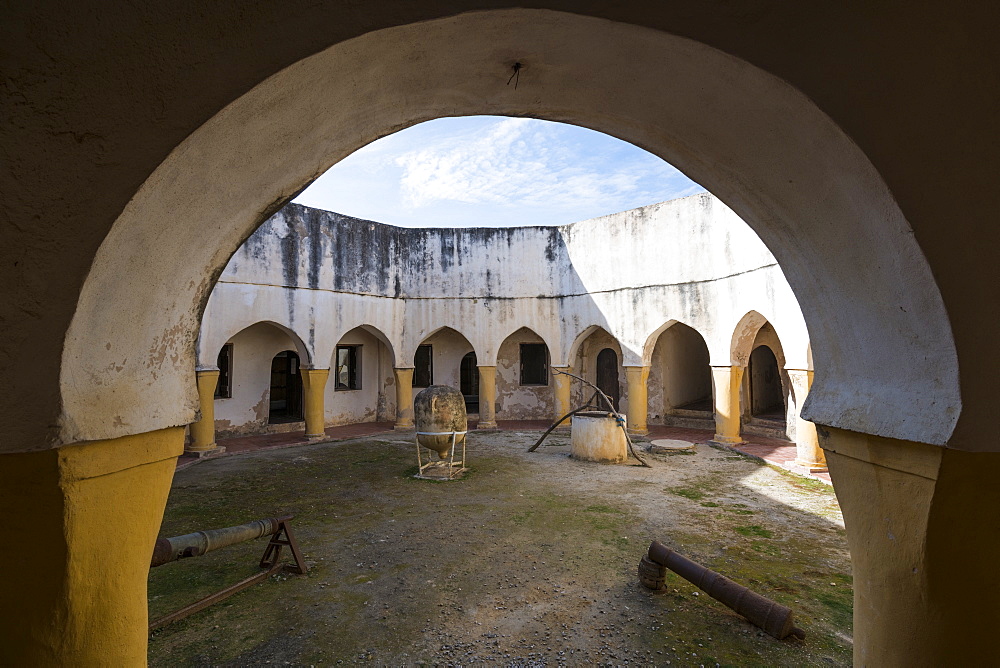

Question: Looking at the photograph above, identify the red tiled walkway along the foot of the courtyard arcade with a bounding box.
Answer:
[177,419,830,483]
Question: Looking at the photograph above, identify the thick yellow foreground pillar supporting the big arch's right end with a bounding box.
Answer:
[818,427,1000,666]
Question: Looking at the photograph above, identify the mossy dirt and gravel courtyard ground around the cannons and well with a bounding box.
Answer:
[149,432,852,666]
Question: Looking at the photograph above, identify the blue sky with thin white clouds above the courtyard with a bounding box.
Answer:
[295,116,704,227]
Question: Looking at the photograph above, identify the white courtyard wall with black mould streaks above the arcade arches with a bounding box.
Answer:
[199,194,809,434]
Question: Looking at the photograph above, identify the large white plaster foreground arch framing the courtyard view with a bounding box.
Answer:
[62,9,961,445]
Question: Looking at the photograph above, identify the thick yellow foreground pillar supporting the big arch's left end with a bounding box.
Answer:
[0,427,184,666]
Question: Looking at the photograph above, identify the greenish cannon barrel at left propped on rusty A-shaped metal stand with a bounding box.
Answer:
[149,515,309,631]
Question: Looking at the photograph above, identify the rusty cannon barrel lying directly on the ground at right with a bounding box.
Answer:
[639,540,806,640]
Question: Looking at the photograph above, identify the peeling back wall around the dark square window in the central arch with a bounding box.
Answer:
[496,328,555,420]
